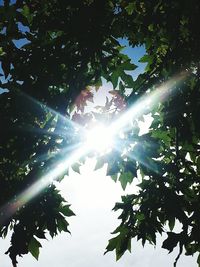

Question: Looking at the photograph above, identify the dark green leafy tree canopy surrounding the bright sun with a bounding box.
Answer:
[0,0,200,266]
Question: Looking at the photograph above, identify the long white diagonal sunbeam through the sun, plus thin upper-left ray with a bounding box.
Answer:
[0,73,187,223]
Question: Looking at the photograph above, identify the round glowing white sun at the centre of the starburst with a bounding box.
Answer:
[86,124,114,153]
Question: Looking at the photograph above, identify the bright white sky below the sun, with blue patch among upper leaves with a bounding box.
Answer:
[0,6,196,267]
